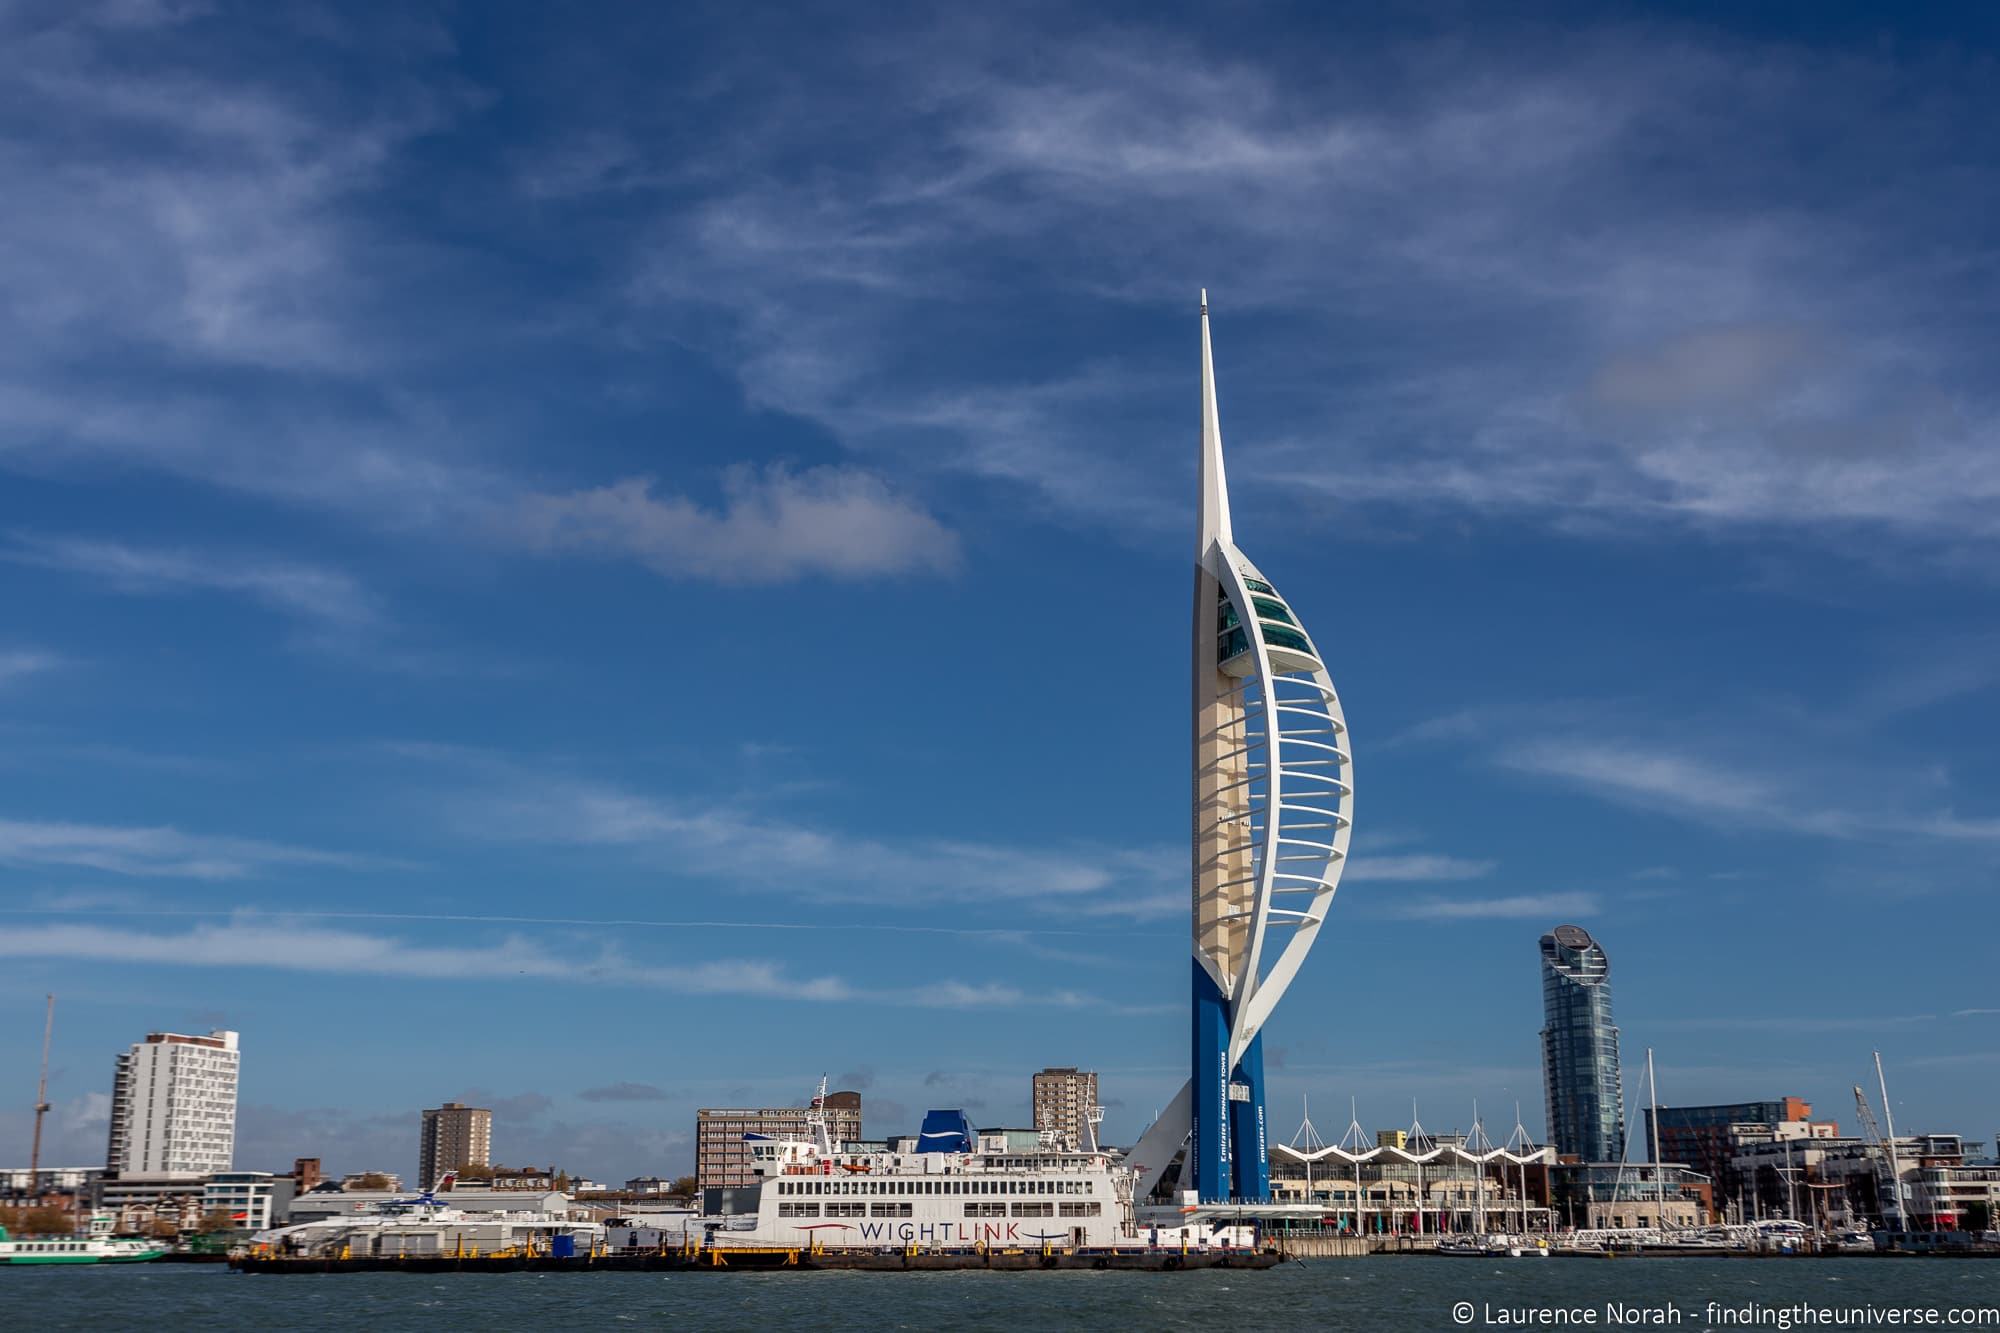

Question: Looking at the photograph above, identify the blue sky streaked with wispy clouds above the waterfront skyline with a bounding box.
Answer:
[0,0,2000,1177]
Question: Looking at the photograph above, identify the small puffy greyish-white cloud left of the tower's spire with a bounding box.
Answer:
[512,466,958,582]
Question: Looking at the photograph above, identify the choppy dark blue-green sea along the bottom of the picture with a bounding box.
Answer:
[0,1255,2000,1333]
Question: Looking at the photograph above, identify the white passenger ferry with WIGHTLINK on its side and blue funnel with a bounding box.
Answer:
[720,1088,1160,1249]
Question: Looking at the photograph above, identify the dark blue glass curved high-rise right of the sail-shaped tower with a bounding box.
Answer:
[1542,925,1632,1163]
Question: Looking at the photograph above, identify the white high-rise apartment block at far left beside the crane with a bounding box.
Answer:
[104,1031,242,1175]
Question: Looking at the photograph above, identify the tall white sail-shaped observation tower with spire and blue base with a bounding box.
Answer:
[1130,292,1354,1203]
